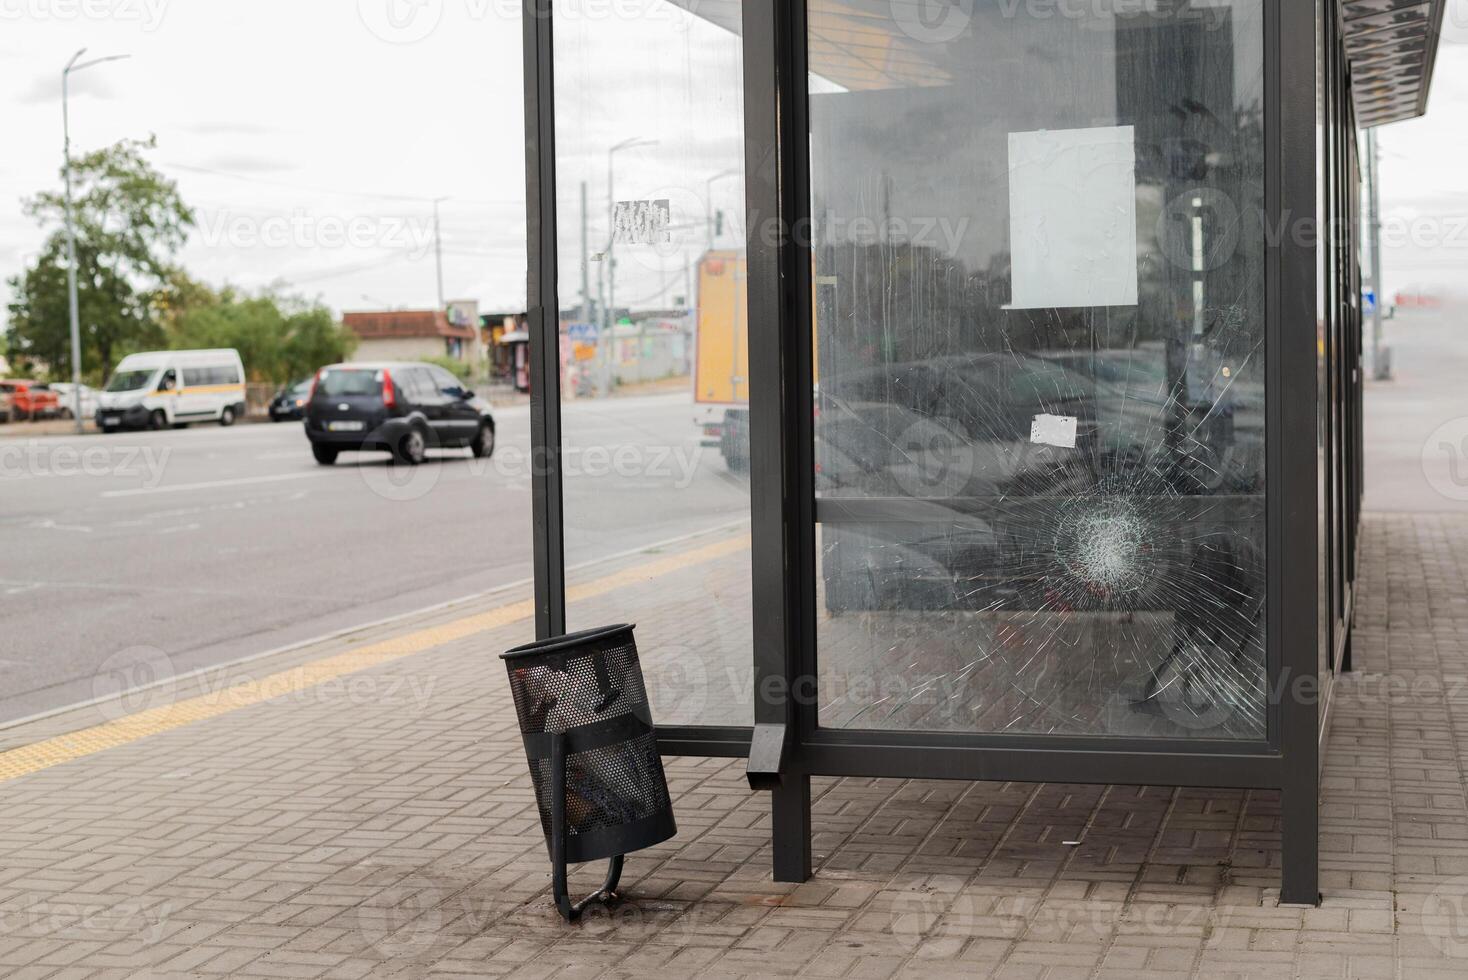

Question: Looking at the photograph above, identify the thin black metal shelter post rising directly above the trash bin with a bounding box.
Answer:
[521,0,565,640]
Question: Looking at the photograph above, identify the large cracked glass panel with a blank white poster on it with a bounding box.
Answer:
[809,0,1265,739]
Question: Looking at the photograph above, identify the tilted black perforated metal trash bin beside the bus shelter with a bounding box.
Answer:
[501,624,678,920]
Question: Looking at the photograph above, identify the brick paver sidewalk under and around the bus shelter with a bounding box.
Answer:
[0,515,1468,979]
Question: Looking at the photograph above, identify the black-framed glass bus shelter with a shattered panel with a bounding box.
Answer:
[524,0,1443,904]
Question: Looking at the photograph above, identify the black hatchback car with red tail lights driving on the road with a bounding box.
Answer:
[305,362,495,465]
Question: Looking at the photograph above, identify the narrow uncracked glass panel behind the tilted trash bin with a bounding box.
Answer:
[555,0,753,725]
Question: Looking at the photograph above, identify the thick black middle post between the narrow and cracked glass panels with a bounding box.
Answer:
[743,0,815,882]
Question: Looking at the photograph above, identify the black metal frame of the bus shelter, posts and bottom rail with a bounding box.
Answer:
[524,0,1359,904]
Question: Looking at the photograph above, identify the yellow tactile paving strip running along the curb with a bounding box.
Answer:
[0,535,750,782]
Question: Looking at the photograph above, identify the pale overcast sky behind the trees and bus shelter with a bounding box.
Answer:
[0,0,1468,325]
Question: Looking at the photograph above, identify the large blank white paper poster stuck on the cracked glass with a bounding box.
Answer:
[1009,126,1136,310]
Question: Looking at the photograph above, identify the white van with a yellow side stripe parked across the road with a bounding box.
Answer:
[97,351,245,431]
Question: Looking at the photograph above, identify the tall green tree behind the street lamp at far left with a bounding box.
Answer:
[9,138,194,380]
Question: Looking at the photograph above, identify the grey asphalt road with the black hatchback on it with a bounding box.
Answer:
[0,395,749,722]
